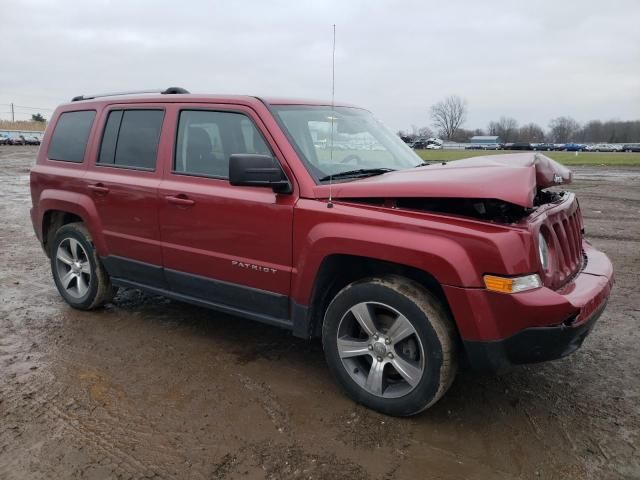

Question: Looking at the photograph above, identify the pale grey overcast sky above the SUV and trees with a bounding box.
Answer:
[0,0,640,130]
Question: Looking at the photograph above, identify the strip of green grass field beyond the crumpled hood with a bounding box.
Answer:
[416,150,640,167]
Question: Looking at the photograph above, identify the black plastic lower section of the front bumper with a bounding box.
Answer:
[463,301,607,372]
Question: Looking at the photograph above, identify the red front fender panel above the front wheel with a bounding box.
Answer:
[291,200,535,305]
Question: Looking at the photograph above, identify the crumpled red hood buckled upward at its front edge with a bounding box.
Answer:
[320,153,572,224]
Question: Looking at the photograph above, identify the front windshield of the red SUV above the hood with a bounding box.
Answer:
[274,105,422,182]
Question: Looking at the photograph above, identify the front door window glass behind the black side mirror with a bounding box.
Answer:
[173,110,271,178]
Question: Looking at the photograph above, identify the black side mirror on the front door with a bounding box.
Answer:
[229,153,291,193]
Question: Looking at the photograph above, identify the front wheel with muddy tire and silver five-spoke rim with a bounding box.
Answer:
[322,275,458,416]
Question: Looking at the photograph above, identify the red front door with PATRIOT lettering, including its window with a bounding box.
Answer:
[159,104,297,323]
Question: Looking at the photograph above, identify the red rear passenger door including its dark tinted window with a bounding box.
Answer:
[85,104,171,288]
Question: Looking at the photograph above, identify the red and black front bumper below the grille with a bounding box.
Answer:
[445,243,613,371]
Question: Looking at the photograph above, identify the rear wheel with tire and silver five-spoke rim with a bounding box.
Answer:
[49,222,113,310]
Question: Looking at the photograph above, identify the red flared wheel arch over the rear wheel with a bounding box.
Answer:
[35,189,109,256]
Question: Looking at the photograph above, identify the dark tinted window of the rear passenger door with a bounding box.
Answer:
[98,110,164,170]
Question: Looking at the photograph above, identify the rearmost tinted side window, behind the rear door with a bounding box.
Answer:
[47,110,96,163]
